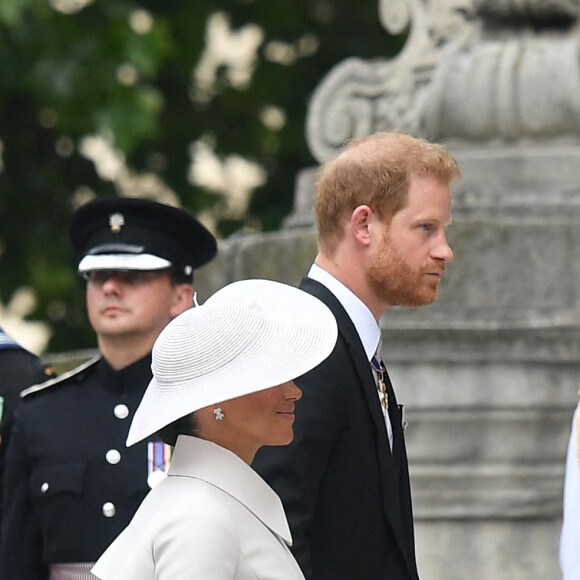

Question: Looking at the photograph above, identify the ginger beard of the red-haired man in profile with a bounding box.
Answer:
[366,236,445,307]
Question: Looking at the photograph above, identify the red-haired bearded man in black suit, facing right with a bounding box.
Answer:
[254,133,459,580]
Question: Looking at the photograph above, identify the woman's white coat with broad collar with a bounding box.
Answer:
[92,435,304,580]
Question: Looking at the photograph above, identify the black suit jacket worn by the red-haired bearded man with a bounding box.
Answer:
[253,278,418,580]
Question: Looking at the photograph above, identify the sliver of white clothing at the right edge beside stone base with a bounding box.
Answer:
[560,396,580,580]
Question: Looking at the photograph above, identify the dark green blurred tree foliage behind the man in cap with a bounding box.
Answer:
[0,0,404,352]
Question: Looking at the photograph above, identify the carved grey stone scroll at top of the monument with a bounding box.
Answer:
[306,0,580,161]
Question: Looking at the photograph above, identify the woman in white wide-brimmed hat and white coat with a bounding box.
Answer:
[92,280,337,580]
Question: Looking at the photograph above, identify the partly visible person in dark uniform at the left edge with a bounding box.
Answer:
[0,327,56,529]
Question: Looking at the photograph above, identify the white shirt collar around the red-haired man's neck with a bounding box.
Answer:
[308,264,381,361]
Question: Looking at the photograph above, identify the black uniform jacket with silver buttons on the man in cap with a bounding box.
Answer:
[0,356,160,580]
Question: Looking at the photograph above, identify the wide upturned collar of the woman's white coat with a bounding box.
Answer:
[168,435,292,545]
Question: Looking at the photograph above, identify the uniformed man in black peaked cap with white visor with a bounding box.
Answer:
[0,197,217,580]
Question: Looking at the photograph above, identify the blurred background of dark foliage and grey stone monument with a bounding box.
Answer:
[0,0,580,580]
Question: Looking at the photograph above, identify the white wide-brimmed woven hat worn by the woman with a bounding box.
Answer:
[127,280,338,446]
